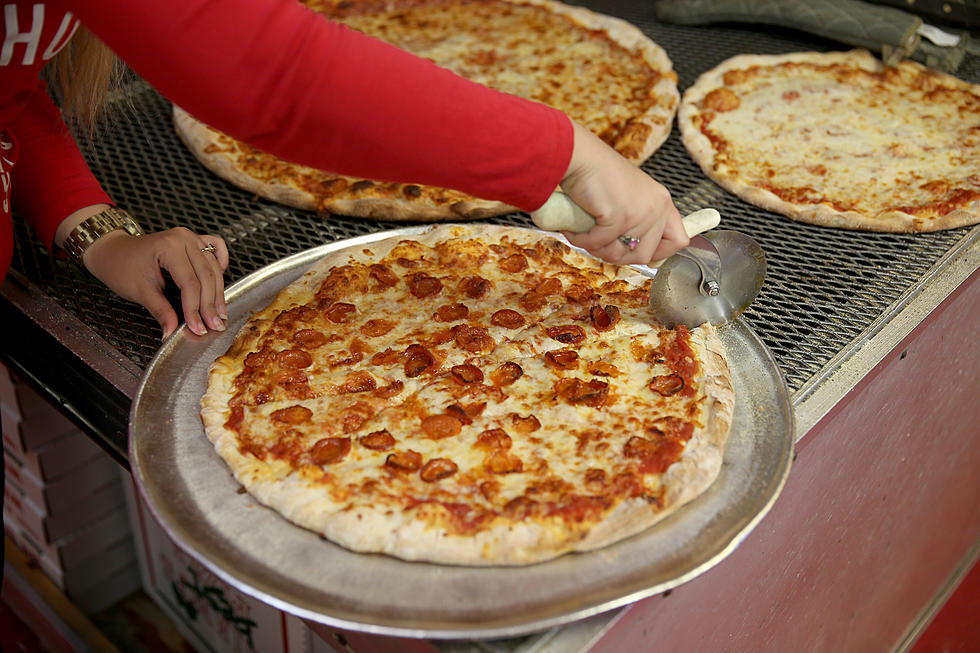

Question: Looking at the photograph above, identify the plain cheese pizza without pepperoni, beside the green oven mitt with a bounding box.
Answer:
[677,50,980,232]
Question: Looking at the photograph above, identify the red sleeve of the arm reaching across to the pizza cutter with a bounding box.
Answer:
[64,0,573,210]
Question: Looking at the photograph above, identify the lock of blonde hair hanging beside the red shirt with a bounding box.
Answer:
[46,27,125,136]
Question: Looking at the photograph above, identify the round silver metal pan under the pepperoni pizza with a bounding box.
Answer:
[130,227,793,639]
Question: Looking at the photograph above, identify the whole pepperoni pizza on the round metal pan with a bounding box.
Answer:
[201,223,734,566]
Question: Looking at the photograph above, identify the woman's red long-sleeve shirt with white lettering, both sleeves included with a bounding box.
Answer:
[0,0,572,278]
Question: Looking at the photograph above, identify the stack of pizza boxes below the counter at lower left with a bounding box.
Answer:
[0,365,139,614]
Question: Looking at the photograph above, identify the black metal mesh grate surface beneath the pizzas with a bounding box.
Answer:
[12,0,980,391]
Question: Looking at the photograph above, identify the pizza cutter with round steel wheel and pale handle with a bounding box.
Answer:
[531,191,766,328]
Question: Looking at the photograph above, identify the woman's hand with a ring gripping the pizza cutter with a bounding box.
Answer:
[561,123,690,264]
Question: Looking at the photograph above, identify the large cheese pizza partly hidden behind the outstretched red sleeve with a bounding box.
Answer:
[173,0,680,221]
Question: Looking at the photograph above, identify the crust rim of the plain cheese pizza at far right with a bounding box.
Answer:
[677,50,980,233]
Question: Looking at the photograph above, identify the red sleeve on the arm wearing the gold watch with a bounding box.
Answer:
[7,88,112,249]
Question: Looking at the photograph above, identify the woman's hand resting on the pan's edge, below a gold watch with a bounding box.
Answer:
[82,227,228,338]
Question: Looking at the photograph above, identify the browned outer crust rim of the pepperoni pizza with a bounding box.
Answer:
[201,224,734,566]
